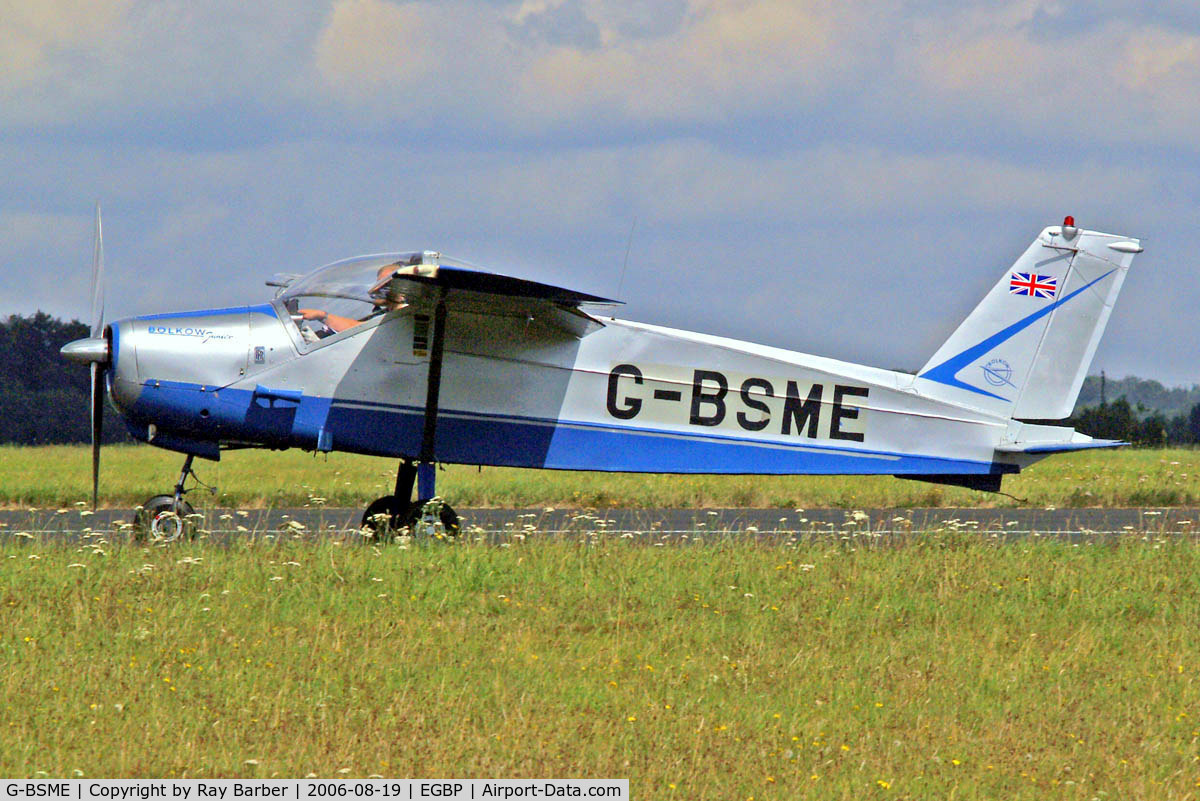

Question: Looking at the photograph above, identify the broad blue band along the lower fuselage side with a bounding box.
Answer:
[130,381,1015,475]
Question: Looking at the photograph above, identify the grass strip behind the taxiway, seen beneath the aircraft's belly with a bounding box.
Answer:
[0,446,1200,508]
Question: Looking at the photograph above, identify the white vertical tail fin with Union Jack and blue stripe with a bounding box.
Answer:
[917,217,1142,420]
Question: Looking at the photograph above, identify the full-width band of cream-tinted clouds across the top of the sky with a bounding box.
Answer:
[9,0,1200,150]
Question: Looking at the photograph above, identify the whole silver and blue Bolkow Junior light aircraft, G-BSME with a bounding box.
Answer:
[62,209,1142,538]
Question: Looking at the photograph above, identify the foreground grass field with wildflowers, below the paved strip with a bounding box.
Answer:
[7,531,1200,801]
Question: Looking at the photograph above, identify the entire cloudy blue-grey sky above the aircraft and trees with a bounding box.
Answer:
[0,0,1200,385]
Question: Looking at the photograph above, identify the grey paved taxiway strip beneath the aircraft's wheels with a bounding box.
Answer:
[0,508,1200,537]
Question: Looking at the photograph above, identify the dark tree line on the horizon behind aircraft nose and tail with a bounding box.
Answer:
[0,312,1200,446]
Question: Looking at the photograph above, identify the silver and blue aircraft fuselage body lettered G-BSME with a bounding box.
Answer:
[109,300,1032,475]
